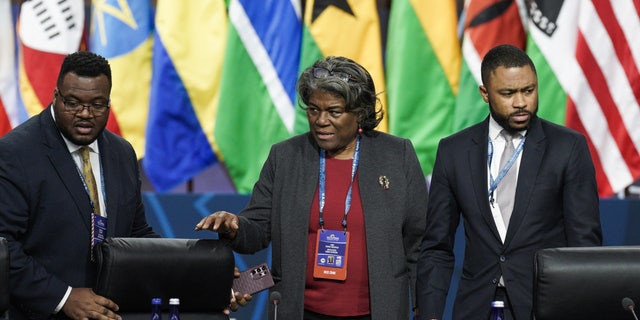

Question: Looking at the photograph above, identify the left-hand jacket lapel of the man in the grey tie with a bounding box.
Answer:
[468,121,502,242]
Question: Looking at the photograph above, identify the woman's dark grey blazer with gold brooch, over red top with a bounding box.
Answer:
[228,132,428,320]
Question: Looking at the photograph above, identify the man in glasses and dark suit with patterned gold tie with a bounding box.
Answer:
[0,52,158,320]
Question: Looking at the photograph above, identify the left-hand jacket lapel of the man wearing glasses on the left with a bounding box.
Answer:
[39,107,91,230]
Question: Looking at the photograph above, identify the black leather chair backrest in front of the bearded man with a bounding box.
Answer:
[533,246,640,320]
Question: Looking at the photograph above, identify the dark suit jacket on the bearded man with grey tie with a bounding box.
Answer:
[418,117,602,320]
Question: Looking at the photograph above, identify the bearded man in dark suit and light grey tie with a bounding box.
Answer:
[417,45,602,320]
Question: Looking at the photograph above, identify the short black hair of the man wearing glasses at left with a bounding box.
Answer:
[56,51,111,89]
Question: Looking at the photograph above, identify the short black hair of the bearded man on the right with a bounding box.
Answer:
[480,44,537,85]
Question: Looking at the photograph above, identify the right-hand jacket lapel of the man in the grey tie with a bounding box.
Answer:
[505,118,546,245]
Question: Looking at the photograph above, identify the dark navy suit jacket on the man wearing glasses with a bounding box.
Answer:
[0,107,157,319]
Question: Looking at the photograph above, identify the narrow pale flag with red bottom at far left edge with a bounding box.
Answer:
[0,0,24,136]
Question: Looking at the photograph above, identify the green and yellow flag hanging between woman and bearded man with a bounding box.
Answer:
[386,0,462,174]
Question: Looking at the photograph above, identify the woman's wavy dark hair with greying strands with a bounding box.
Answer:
[296,56,384,132]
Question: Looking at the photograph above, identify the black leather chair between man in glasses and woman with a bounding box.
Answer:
[95,238,235,320]
